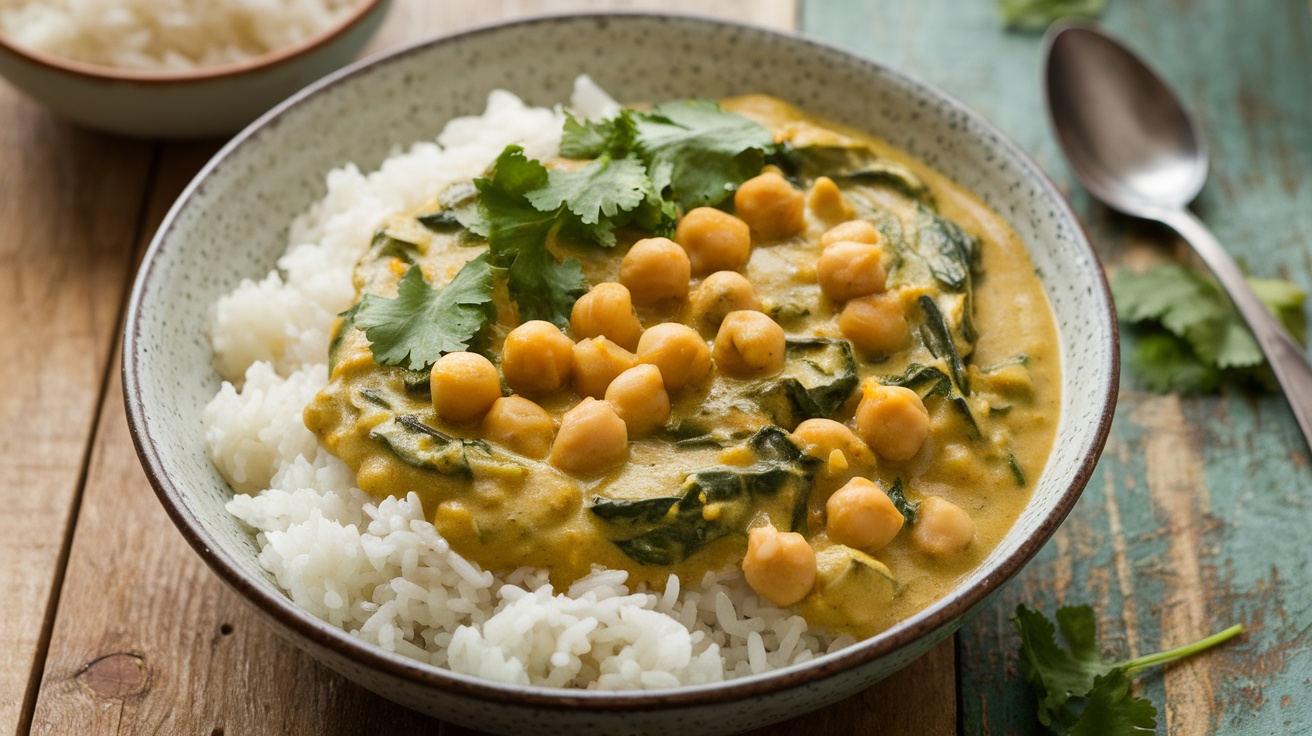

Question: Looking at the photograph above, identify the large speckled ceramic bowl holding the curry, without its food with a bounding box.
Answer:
[123,16,1118,735]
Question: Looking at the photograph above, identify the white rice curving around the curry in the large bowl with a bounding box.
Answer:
[205,77,850,690]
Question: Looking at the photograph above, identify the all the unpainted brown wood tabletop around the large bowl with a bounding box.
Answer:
[12,0,956,735]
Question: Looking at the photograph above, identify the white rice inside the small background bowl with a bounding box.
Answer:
[0,0,361,71]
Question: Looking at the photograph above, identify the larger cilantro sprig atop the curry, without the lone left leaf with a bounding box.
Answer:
[464,100,774,327]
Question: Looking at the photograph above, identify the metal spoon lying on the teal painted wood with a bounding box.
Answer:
[1044,24,1312,445]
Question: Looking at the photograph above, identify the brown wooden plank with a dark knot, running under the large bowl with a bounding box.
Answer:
[34,0,956,735]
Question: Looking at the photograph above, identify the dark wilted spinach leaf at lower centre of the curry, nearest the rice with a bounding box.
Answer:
[588,425,819,565]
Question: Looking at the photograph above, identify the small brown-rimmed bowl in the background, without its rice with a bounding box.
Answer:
[0,0,391,138]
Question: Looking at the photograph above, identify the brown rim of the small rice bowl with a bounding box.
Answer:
[0,0,392,87]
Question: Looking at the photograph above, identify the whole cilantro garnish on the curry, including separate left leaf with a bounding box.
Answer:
[354,100,774,370]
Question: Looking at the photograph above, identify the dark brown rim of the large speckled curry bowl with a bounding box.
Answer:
[121,10,1120,712]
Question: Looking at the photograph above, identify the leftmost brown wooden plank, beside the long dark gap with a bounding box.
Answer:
[0,81,152,732]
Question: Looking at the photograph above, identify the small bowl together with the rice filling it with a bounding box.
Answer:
[0,0,391,138]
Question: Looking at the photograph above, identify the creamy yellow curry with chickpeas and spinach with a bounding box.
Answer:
[304,96,1059,636]
